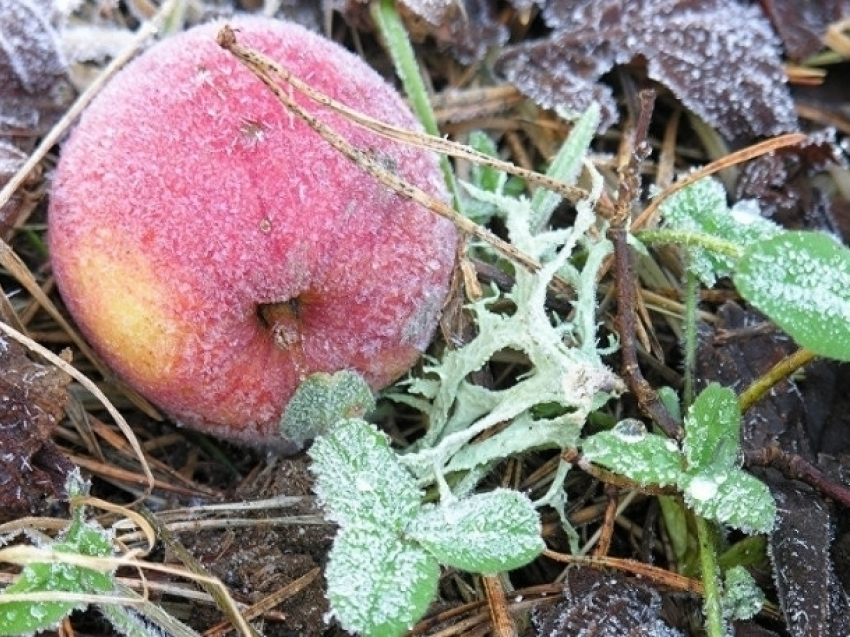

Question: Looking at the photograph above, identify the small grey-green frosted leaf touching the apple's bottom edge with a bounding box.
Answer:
[280,370,375,442]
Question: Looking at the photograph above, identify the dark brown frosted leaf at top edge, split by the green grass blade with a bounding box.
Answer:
[324,0,504,64]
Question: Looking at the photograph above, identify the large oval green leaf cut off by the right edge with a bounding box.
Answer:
[734,232,850,361]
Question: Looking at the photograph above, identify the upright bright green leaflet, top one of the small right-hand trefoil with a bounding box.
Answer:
[684,383,741,474]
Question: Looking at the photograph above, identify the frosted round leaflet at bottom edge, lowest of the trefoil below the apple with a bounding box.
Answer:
[325,527,440,637]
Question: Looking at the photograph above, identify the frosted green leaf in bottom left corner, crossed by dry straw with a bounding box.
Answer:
[0,484,113,636]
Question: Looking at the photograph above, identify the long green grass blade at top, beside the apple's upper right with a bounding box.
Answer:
[370,0,461,212]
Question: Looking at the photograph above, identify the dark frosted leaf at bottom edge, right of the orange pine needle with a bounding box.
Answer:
[534,567,682,637]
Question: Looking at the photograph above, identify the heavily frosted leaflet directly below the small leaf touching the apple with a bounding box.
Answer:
[309,419,422,531]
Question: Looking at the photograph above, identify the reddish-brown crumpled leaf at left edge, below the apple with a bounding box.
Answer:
[0,337,74,524]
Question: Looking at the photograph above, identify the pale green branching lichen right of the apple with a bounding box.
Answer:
[392,109,625,508]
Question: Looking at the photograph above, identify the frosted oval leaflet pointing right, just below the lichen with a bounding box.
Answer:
[407,489,545,574]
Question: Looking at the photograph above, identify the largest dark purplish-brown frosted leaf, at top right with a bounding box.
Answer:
[496,0,797,140]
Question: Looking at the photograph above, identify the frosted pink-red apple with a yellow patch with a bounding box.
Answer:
[48,18,457,446]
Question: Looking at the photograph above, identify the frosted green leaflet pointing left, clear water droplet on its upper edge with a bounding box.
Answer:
[582,419,684,487]
